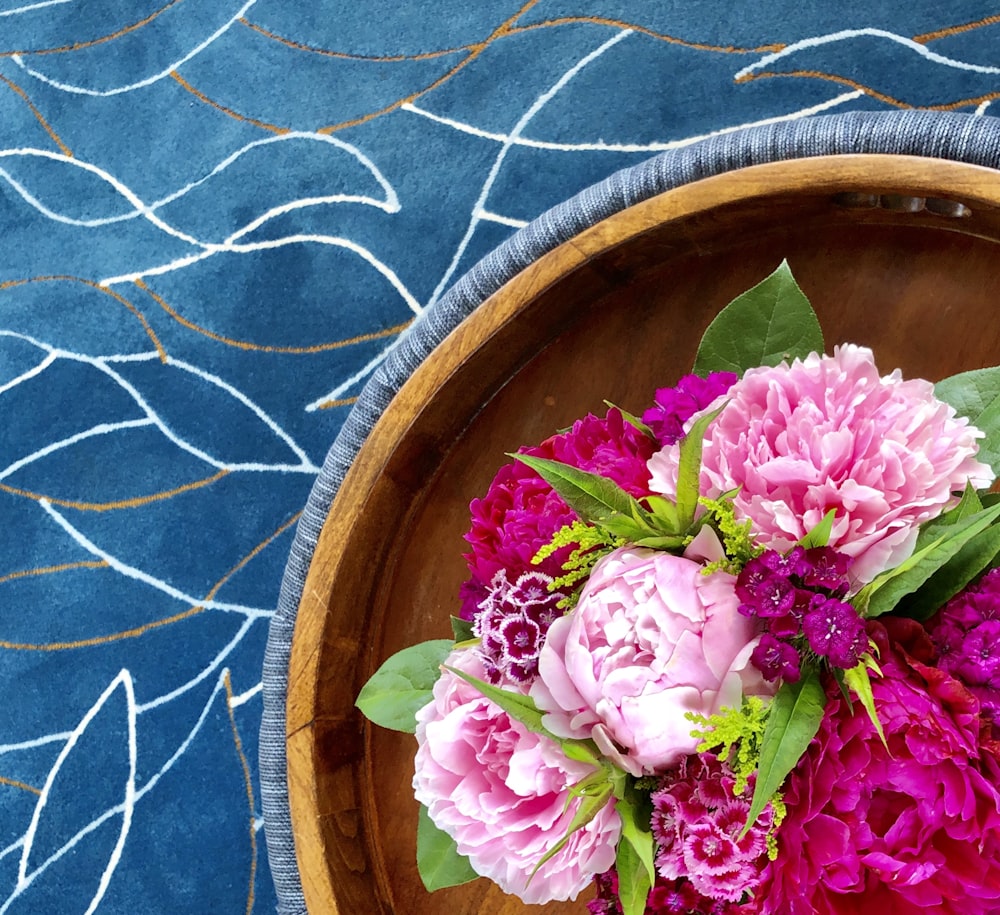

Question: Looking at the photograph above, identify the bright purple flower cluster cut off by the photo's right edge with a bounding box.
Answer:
[928,569,1000,725]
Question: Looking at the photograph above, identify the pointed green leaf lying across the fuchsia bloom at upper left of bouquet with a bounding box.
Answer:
[509,454,660,541]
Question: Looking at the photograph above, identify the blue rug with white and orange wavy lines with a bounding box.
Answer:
[0,0,1000,915]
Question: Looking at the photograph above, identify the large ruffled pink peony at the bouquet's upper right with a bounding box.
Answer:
[649,344,993,582]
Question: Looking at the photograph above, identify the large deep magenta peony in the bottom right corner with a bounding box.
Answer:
[756,618,1000,915]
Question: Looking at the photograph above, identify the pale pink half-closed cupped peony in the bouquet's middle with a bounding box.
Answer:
[532,547,772,775]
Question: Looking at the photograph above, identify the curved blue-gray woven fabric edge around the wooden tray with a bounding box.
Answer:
[260,111,1000,915]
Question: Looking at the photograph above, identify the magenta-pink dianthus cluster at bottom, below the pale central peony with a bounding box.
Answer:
[651,753,773,902]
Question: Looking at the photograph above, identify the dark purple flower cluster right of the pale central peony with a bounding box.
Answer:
[736,546,868,683]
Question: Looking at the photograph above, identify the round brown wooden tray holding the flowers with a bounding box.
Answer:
[287,155,1000,915]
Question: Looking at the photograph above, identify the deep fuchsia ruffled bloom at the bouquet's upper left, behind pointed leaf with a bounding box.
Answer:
[461,409,655,620]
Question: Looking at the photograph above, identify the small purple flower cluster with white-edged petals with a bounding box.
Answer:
[472,569,563,686]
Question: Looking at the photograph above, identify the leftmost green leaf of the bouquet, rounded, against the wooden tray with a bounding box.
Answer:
[354,639,454,734]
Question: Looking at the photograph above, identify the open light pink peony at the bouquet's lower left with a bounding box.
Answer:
[413,651,621,903]
